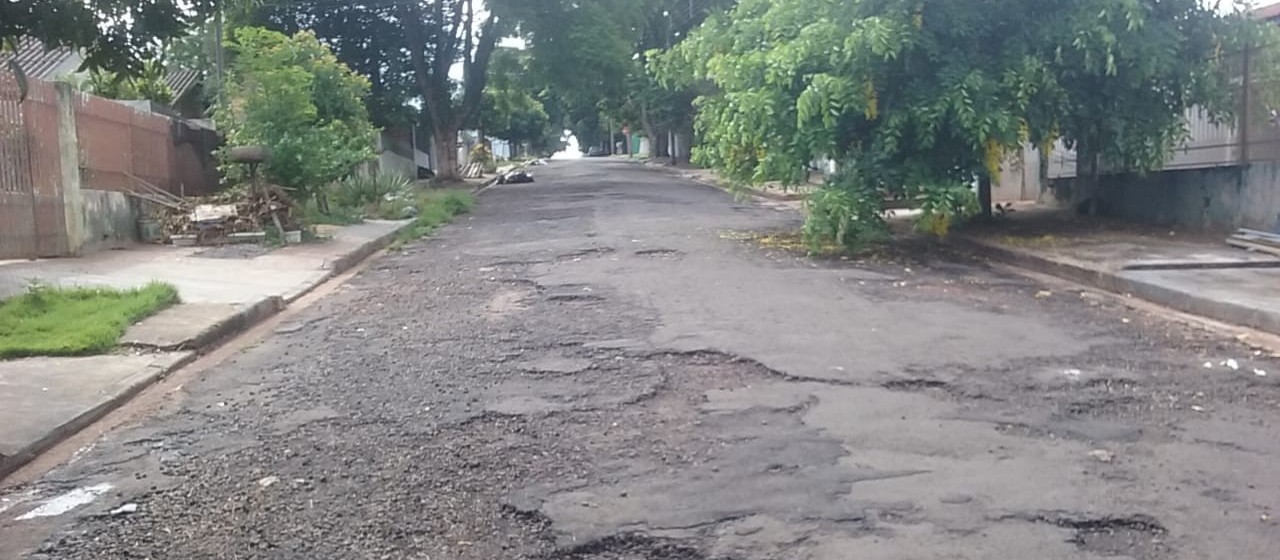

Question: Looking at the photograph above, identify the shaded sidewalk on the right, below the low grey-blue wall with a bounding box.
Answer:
[954,210,1280,334]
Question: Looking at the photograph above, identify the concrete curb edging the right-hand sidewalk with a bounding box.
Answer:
[951,235,1280,334]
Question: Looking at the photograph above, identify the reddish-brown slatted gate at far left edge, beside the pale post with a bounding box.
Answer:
[0,69,67,258]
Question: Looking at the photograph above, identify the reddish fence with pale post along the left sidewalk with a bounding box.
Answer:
[0,72,218,260]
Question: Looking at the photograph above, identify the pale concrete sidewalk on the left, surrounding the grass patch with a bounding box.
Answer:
[0,221,408,476]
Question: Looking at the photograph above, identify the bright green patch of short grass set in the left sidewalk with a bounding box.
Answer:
[0,283,178,359]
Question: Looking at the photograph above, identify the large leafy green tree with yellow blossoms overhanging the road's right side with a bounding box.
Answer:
[655,0,1230,243]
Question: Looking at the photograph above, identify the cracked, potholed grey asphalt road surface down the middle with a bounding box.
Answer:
[0,160,1280,560]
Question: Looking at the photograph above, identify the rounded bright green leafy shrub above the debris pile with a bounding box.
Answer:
[215,27,375,205]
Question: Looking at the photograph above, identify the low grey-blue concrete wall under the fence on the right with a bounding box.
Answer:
[1051,162,1280,231]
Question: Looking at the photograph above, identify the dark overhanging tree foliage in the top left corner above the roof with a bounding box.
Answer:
[0,0,216,74]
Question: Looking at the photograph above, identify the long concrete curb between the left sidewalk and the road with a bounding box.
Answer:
[0,221,412,478]
